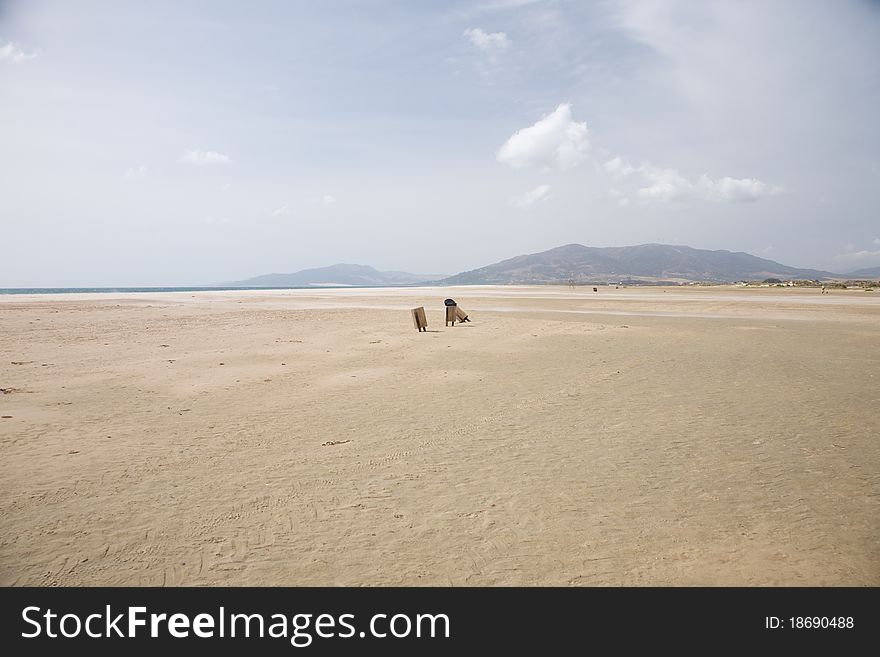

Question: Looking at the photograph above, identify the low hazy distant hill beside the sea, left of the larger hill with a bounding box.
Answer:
[228,264,442,287]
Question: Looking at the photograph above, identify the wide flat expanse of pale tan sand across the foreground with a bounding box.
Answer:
[0,287,880,586]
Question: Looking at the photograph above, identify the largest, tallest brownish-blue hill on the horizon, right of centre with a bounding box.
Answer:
[440,244,835,285]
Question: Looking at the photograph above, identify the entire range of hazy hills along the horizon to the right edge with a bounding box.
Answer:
[233,244,880,287]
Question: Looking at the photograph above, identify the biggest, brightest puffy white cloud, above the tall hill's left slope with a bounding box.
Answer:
[496,103,589,169]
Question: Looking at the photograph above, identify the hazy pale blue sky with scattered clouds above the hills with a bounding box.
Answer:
[0,0,880,287]
